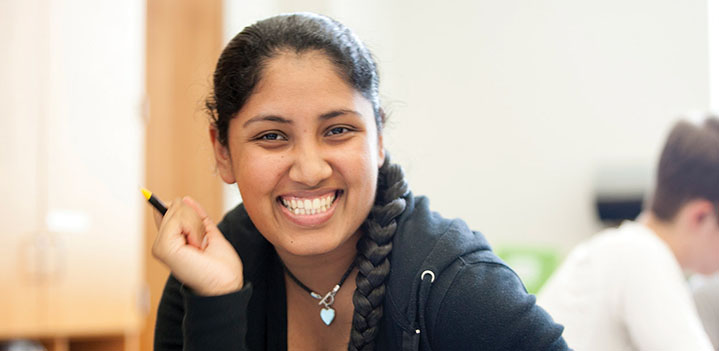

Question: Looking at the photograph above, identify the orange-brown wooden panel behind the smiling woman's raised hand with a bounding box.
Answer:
[141,0,225,350]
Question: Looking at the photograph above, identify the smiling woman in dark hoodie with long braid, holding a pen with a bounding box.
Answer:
[153,13,567,350]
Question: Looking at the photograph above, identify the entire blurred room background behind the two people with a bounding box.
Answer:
[0,0,719,351]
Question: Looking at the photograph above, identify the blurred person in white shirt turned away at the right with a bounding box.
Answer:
[538,117,719,351]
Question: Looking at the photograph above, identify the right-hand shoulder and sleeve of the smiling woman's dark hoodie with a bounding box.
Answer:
[385,197,566,350]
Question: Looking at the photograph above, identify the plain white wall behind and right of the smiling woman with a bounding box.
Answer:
[226,0,709,250]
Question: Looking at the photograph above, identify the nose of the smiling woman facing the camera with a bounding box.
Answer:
[290,145,332,187]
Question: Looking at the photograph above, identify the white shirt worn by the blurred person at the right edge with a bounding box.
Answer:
[538,221,712,351]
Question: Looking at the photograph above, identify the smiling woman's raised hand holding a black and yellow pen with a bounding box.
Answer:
[152,196,243,296]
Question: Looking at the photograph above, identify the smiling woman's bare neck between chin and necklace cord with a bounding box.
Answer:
[275,231,361,295]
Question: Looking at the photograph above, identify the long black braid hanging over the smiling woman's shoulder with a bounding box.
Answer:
[349,155,409,351]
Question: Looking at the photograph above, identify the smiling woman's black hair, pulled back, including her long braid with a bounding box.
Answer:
[206,13,408,350]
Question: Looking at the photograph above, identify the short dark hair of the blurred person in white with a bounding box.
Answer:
[650,116,719,221]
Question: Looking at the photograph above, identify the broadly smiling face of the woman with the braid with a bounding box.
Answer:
[213,52,384,256]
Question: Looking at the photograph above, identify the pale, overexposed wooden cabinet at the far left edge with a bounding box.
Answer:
[0,0,148,351]
